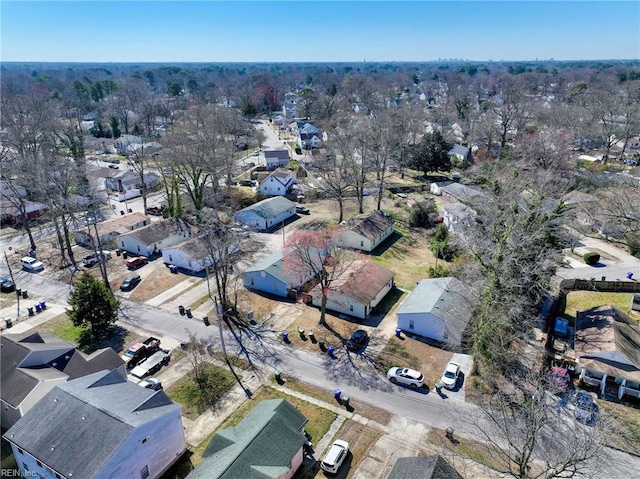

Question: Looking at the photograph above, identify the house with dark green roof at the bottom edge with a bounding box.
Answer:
[187,399,307,479]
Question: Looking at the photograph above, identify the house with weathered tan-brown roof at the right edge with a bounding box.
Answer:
[574,304,640,399]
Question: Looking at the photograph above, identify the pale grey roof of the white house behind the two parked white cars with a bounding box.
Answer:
[396,277,473,331]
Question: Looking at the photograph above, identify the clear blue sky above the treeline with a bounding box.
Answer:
[0,0,640,62]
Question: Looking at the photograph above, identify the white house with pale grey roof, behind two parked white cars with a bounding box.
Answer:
[396,277,473,346]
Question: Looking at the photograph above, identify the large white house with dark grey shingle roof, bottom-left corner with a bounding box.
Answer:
[3,371,186,479]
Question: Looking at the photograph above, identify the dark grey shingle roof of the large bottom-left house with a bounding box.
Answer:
[4,371,181,479]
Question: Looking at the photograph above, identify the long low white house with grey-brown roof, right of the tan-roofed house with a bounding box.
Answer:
[116,218,191,256]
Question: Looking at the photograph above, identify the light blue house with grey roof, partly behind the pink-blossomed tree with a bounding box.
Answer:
[242,250,322,298]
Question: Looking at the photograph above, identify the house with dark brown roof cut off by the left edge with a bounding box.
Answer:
[0,332,126,427]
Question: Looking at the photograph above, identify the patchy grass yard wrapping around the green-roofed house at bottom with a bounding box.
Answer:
[190,386,337,465]
